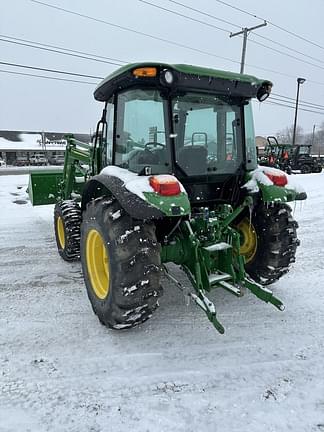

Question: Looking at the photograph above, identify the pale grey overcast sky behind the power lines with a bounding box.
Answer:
[0,0,324,135]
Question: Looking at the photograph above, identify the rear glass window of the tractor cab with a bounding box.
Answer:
[172,93,243,176]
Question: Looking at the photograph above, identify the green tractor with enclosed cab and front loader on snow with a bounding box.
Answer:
[29,63,306,333]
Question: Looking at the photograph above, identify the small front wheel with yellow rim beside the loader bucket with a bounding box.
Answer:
[54,200,81,261]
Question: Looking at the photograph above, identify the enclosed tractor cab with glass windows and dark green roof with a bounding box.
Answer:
[94,64,271,201]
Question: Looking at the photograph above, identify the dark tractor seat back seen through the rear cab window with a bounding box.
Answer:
[177,145,208,175]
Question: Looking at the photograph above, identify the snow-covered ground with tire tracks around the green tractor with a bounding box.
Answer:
[0,174,324,432]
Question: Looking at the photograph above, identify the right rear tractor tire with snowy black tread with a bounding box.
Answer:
[238,204,299,285]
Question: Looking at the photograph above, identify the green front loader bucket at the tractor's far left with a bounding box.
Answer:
[28,170,63,206]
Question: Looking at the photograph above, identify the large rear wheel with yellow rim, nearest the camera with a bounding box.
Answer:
[81,197,161,329]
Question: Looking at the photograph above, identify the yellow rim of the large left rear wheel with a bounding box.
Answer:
[86,229,110,300]
